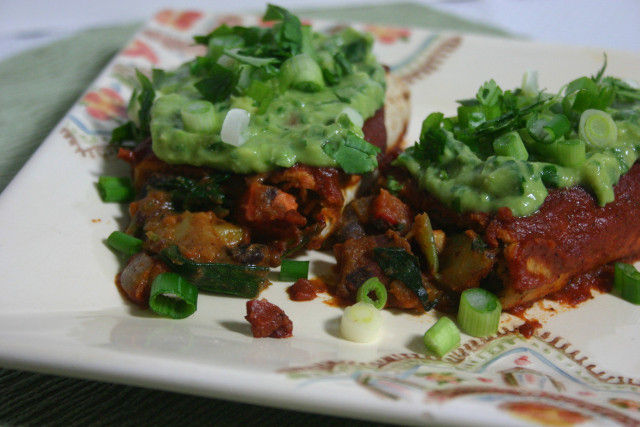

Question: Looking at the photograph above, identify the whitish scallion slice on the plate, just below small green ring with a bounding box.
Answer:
[340,302,382,343]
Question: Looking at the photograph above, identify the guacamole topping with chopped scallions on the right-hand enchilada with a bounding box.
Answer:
[394,63,640,216]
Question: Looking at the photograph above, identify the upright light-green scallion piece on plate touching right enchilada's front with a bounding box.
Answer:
[458,288,502,337]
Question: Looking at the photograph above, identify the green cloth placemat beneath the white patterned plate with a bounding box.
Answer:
[0,3,506,426]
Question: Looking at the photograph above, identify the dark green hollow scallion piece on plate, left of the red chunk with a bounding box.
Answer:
[149,273,198,319]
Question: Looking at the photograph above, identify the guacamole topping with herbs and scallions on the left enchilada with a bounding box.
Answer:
[113,5,385,173]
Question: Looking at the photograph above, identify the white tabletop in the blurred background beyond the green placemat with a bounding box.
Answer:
[0,0,640,60]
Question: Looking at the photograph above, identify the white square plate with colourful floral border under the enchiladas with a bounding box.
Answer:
[0,11,640,425]
